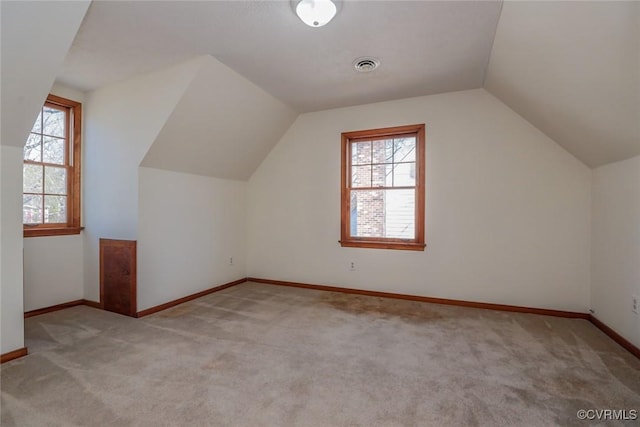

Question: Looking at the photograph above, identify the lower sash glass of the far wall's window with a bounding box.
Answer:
[350,190,415,239]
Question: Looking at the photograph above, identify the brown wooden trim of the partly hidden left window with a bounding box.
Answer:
[23,95,84,237]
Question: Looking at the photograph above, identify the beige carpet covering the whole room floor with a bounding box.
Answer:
[1,283,640,427]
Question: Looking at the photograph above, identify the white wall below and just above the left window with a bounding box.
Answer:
[24,84,85,311]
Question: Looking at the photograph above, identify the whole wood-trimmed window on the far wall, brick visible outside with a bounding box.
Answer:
[340,124,425,251]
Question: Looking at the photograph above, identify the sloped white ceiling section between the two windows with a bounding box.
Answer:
[141,55,297,180]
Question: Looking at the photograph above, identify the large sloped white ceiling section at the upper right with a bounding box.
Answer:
[485,1,640,167]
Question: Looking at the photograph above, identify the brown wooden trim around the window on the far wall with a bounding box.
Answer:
[340,124,426,251]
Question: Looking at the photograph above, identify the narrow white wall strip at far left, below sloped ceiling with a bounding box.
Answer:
[0,145,24,354]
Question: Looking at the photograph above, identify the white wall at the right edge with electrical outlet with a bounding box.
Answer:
[591,156,640,346]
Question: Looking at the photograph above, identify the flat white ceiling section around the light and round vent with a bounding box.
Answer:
[60,0,500,112]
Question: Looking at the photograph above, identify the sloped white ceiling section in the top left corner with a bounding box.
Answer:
[0,0,90,147]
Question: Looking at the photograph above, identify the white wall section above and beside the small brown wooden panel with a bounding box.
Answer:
[83,61,199,301]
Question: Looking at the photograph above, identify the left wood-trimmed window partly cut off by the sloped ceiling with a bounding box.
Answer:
[22,95,82,237]
